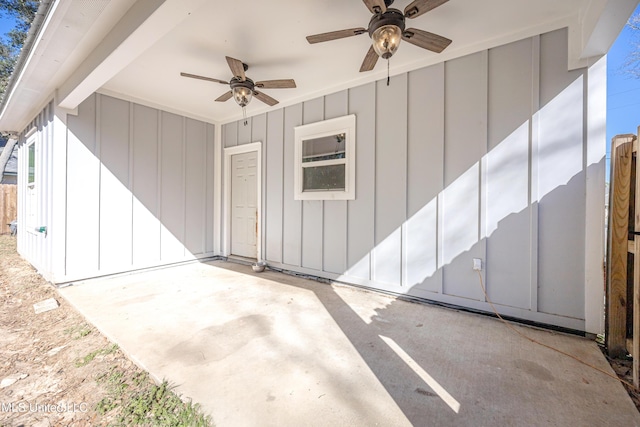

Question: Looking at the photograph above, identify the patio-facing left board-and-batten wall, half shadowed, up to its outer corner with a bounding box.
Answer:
[65,94,215,280]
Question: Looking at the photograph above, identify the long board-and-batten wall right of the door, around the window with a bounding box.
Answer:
[222,29,605,330]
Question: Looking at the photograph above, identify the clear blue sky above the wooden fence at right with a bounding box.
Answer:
[607,5,640,171]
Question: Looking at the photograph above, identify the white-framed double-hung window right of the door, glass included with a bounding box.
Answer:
[294,115,356,200]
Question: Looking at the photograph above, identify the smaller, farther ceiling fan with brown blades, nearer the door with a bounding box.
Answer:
[180,56,296,118]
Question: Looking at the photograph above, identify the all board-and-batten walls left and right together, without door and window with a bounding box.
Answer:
[13,26,606,333]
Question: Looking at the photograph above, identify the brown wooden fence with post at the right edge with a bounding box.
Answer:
[605,128,640,387]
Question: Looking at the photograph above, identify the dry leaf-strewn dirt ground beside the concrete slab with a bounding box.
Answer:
[0,235,209,427]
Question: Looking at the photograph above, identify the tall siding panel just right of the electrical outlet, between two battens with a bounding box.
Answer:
[484,38,538,309]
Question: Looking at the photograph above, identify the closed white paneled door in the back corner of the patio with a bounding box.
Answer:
[231,151,258,258]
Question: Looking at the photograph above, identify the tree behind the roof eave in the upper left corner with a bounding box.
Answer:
[0,0,40,181]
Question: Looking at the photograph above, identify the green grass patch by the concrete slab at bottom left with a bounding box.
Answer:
[96,367,213,427]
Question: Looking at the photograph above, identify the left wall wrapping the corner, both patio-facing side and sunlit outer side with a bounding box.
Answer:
[18,94,215,282]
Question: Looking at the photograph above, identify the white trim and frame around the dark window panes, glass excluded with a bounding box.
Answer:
[294,114,356,200]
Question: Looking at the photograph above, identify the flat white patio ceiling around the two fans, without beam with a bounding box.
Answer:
[104,0,585,122]
